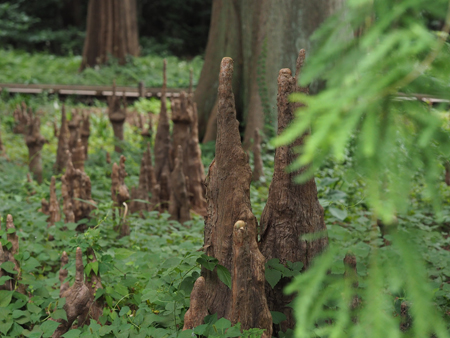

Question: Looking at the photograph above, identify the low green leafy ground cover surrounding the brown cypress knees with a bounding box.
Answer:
[0,93,450,338]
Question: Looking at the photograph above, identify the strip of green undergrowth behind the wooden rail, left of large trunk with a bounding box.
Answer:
[0,50,203,88]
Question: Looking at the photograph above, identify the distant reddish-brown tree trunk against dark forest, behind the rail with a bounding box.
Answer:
[80,0,139,71]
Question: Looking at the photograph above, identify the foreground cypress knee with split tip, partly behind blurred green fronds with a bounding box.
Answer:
[260,50,328,331]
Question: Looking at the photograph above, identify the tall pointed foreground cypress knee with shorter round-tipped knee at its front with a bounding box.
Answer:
[203,58,272,337]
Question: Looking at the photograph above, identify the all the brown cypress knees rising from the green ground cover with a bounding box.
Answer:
[0,50,362,337]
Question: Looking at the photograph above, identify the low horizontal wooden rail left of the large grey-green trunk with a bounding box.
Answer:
[0,83,182,97]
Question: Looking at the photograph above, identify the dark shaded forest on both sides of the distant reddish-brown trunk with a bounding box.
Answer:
[0,0,212,58]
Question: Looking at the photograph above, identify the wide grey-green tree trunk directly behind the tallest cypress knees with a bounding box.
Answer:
[194,0,343,148]
